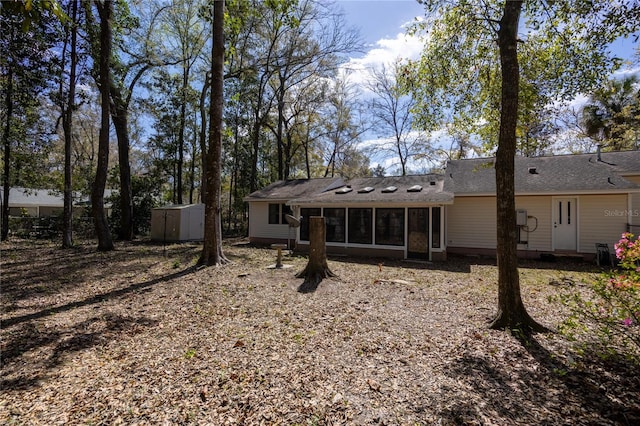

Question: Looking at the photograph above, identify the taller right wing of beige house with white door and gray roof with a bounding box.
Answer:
[446,151,640,258]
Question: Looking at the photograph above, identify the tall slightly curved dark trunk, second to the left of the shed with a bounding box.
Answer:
[91,0,113,251]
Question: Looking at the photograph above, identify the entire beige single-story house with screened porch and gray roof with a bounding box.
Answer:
[245,151,640,260]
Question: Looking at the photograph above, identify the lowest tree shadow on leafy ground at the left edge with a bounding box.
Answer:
[0,313,158,391]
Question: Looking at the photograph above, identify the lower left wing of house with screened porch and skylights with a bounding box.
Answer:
[245,174,453,260]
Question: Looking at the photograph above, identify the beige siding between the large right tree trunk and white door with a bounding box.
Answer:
[516,196,552,251]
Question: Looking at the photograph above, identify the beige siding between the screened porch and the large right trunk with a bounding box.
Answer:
[446,197,496,249]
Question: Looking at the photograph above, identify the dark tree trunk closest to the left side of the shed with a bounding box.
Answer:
[110,84,133,241]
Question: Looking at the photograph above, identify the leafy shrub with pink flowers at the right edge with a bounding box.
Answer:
[558,233,640,364]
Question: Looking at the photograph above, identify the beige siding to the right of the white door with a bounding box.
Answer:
[578,194,628,253]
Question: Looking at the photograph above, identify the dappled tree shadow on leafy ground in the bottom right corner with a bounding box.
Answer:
[439,336,640,425]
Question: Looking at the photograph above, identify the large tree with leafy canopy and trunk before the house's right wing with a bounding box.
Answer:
[406,0,640,331]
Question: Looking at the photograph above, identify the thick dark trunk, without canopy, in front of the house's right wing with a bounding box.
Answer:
[490,0,544,331]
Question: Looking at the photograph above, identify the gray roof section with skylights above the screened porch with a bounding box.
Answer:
[290,174,453,205]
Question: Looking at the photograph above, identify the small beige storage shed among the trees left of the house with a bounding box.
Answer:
[151,204,204,241]
